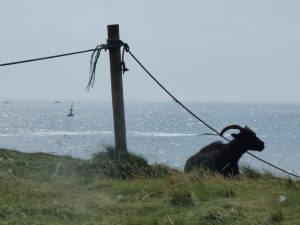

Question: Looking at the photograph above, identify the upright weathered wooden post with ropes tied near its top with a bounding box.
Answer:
[107,24,127,152]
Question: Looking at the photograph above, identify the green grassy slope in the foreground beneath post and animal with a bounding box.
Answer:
[0,148,300,225]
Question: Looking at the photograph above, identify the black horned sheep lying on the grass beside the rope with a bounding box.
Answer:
[184,125,265,177]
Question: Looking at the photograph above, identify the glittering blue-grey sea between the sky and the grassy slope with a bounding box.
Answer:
[0,101,300,175]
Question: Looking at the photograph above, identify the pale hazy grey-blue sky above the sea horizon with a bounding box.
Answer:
[0,0,300,101]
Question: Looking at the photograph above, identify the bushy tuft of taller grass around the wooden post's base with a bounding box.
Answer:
[77,147,171,179]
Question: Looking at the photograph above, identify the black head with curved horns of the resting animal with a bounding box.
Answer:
[220,125,265,151]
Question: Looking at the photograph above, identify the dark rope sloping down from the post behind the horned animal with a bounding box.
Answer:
[126,48,300,178]
